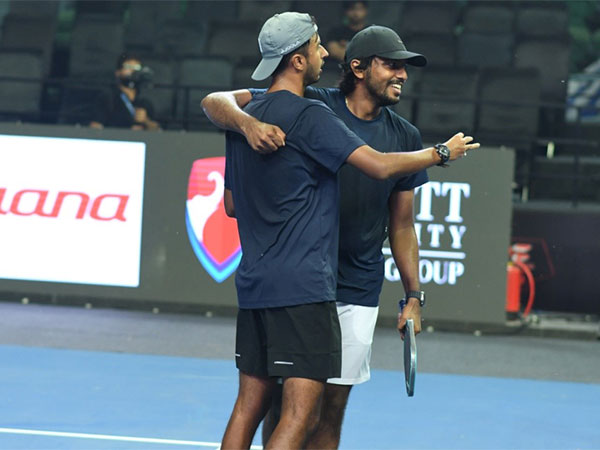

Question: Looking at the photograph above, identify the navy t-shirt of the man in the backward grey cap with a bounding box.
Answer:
[225,91,364,309]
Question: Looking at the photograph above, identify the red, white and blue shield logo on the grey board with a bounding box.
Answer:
[185,156,242,283]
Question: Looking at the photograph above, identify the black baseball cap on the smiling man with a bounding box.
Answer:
[344,25,427,67]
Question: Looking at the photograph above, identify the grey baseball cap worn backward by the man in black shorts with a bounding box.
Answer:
[252,12,318,81]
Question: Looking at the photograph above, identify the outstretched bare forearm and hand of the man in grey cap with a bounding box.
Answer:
[347,133,479,180]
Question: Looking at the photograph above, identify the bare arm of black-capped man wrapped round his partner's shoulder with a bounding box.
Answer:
[202,89,285,153]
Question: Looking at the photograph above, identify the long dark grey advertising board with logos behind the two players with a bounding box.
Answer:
[0,125,513,323]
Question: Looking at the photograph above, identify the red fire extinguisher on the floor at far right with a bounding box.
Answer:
[506,243,535,320]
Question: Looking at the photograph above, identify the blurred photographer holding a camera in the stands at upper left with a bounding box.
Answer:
[90,53,160,130]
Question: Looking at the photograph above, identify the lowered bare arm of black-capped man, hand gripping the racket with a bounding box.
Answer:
[388,190,421,334]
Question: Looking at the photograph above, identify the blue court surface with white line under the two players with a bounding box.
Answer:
[0,346,600,449]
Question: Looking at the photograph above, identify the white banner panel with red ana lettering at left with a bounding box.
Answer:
[0,135,146,287]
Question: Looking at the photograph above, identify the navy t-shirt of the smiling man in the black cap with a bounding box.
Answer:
[305,87,429,306]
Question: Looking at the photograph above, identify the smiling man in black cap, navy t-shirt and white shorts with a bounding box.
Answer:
[203,22,478,448]
